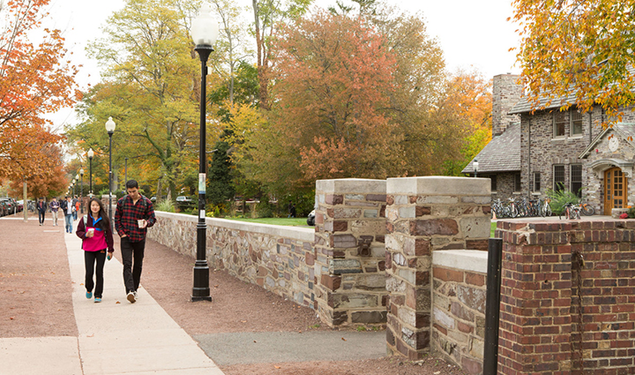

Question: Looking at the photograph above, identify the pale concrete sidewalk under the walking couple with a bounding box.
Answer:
[0,217,223,375]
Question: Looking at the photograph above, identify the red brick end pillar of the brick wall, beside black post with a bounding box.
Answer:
[496,222,577,375]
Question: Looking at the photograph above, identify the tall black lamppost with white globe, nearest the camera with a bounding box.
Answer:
[192,2,218,301]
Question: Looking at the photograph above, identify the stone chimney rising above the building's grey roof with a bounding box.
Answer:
[492,73,523,137]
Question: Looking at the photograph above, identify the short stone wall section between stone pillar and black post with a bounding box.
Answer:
[431,250,488,374]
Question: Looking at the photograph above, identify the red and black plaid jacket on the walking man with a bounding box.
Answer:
[115,195,157,242]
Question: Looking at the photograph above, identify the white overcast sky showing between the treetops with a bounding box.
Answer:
[47,0,519,129]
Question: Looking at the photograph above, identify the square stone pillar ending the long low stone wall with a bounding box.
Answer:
[314,179,388,326]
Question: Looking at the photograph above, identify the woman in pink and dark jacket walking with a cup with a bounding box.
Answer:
[75,198,115,303]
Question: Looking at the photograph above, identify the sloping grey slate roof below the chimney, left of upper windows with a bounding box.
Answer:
[461,123,520,174]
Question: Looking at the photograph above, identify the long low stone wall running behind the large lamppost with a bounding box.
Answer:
[148,211,315,308]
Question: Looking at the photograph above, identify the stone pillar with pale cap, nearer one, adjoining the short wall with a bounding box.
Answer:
[386,177,491,360]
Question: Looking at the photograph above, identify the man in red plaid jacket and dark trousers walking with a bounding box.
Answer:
[115,180,156,303]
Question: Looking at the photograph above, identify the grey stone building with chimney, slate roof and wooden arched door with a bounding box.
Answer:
[463,74,635,215]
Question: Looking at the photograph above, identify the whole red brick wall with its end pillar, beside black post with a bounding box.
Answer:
[496,220,635,375]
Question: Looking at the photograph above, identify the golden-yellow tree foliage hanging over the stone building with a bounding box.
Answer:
[513,0,635,118]
